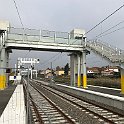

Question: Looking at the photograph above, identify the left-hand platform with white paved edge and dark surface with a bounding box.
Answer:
[0,84,26,124]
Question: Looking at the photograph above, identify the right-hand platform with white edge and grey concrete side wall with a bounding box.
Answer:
[50,83,124,115]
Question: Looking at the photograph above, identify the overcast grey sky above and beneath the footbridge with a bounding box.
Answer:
[0,0,124,68]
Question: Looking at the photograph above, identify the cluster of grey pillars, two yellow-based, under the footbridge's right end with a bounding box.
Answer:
[70,50,87,88]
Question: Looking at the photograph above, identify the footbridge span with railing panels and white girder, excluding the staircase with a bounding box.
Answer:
[5,27,83,52]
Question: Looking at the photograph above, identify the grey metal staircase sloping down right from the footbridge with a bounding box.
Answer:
[86,40,124,63]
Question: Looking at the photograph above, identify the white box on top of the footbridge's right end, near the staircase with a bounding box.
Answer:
[70,29,85,39]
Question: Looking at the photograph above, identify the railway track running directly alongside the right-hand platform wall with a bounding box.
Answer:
[29,79,124,124]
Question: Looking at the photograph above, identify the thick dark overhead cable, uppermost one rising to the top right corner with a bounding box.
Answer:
[84,4,124,35]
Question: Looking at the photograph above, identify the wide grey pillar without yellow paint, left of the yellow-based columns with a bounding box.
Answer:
[70,54,76,86]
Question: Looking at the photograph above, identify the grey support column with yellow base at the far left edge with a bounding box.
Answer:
[0,47,6,89]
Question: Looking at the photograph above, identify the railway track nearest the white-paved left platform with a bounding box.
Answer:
[29,82,76,124]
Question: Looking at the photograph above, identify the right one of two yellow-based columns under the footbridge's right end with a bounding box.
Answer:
[82,51,87,88]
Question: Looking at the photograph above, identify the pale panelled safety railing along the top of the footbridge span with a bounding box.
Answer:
[7,27,82,45]
